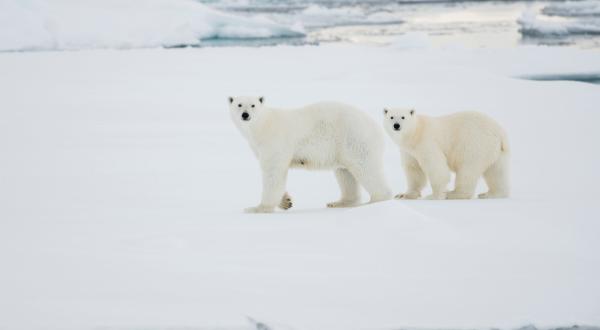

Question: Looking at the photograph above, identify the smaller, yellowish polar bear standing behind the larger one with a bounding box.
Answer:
[383,108,509,199]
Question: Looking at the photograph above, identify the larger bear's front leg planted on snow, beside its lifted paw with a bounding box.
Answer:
[245,163,288,213]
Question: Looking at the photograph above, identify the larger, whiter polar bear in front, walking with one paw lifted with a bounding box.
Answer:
[229,96,391,213]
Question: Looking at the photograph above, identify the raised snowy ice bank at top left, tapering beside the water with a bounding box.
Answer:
[0,0,303,51]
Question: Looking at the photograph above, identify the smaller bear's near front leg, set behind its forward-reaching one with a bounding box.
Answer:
[419,146,450,199]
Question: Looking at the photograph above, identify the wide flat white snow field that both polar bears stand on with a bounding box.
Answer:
[0,36,600,330]
